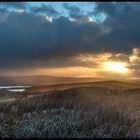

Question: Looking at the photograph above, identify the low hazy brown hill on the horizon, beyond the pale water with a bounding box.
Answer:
[0,76,102,86]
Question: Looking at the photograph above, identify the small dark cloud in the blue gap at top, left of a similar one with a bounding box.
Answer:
[31,4,59,16]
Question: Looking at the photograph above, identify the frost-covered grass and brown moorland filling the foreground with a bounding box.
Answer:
[0,87,140,138]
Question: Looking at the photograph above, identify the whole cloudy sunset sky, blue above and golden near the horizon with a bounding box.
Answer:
[0,2,140,79]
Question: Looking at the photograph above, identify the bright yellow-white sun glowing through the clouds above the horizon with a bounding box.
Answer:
[103,62,128,73]
